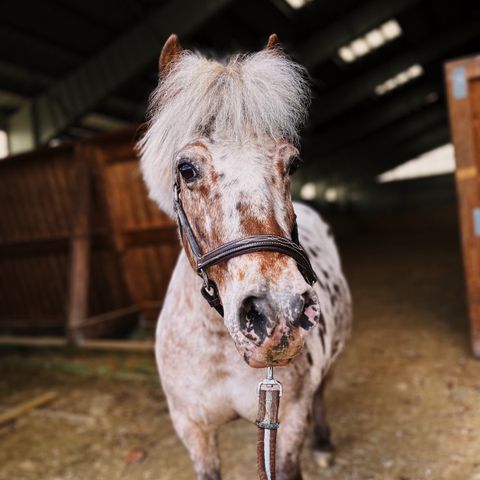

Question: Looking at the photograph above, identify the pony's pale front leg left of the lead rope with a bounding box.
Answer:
[170,411,221,480]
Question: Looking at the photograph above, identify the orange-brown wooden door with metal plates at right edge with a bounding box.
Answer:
[445,56,480,358]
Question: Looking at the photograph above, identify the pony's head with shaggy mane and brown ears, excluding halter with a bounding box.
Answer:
[139,35,319,367]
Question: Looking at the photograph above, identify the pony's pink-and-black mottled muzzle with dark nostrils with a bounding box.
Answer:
[236,289,319,368]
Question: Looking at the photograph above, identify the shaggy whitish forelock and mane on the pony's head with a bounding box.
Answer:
[138,50,310,215]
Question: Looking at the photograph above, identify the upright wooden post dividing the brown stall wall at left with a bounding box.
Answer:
[67,142,92,344]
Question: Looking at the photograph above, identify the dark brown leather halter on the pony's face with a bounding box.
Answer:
[173,178,317,317]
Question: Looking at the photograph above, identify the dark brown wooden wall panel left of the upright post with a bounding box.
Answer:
[0,145,74,332]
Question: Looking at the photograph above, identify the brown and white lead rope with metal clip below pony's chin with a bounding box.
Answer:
[255,367,283,480]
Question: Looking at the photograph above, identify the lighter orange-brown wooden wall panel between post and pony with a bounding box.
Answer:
[92,130,180,325]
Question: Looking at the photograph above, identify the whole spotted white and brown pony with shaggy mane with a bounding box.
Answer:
[138,35,351,480]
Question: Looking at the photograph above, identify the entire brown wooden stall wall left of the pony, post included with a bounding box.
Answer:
[0,125,179,343]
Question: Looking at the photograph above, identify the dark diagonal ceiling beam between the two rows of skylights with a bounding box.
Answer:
[310,19,480,126]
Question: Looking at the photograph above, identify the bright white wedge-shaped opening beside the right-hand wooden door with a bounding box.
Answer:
[377,143,455,183]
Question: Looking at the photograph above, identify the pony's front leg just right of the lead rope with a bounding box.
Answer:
[276,400,311,480]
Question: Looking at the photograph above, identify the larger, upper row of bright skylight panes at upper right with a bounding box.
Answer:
[338,19,402,63]
